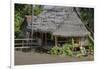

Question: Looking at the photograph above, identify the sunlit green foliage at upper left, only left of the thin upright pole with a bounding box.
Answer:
[14,4,32,38]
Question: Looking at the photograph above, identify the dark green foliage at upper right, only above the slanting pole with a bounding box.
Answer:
[80,8,94,37]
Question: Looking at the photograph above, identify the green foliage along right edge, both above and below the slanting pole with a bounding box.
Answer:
[80,8,94,51]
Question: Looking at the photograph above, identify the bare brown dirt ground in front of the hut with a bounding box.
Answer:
[15,51,94,65]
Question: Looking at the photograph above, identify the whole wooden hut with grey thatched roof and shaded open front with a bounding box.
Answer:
[22,5,89,46]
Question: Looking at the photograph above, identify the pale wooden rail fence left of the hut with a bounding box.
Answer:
[15,38,40,48]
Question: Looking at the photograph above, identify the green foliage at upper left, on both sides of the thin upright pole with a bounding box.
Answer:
[14,4,42,38]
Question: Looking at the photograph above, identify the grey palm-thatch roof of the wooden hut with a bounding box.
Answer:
[27,6,89,37]
